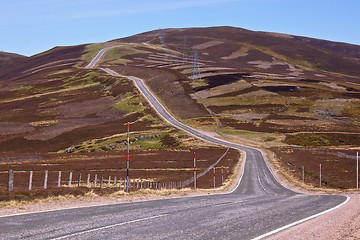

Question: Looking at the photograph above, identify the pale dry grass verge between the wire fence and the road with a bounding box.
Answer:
[0,152,245,212]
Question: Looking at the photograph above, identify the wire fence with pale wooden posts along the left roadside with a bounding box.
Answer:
[0,149,229,192]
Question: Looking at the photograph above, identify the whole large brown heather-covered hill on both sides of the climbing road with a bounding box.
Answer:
[0,27,360,188]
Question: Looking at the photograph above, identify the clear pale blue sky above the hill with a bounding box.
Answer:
[0,0,360,56]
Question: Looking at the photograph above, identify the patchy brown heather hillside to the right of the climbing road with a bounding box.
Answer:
[105,27,360,188]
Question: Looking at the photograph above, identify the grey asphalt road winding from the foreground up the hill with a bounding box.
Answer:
[0,46,347,239]
